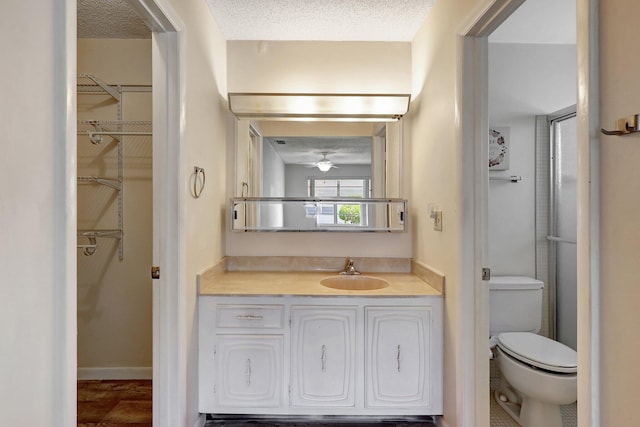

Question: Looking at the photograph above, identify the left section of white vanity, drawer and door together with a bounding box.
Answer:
[198,298,284,413]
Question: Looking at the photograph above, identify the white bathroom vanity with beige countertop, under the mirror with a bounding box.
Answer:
[198,272,442,416]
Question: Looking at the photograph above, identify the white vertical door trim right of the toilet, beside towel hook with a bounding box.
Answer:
[576,0,601,427]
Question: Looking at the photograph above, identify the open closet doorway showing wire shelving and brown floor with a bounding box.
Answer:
[76,2,153,426]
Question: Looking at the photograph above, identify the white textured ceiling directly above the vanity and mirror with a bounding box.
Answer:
[207,0,434,41]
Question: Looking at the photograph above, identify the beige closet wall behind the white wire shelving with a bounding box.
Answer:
[78,39,152,379]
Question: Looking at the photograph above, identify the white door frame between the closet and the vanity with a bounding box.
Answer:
[130,0,188,427]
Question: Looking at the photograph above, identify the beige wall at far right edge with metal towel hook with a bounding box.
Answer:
[599,0,640,426]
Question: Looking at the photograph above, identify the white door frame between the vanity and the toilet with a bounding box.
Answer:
[456,0,524,427]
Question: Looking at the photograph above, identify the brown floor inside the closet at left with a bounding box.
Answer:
[78,380,152,427]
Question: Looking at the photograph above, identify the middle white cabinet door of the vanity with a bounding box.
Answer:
[291,306,356,407]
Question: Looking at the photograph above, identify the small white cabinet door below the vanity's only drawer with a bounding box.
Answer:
[215,335,283,409]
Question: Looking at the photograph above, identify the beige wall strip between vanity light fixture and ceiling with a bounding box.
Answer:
[228,41,411,94]
